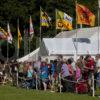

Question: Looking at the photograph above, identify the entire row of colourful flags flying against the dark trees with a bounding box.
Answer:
[0,4,95,49]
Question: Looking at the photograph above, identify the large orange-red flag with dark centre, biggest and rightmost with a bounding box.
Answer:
[76,4,95,26]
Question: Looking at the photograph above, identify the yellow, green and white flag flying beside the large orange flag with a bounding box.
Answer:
[56,10,73,30]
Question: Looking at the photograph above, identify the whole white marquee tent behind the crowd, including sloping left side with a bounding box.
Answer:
[18,27,100,61]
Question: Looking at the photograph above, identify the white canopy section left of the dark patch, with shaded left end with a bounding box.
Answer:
[40,38,75,56]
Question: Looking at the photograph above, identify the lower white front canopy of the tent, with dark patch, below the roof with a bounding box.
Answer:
[40,35,100,56]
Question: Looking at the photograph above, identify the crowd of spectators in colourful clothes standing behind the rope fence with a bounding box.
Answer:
[0,54,100,93]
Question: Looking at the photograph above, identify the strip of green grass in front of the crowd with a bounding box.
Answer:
[0,86,100,100]
